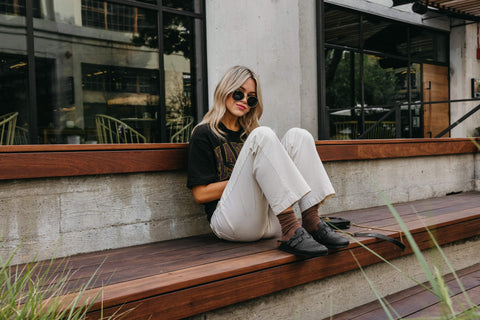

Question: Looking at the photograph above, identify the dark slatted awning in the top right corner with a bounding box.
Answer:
[393,0,480,22]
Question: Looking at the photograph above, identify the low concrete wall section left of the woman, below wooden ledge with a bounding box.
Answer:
[0,172,209,262]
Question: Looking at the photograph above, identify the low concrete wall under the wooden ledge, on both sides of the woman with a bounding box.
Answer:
[0,155,480,263]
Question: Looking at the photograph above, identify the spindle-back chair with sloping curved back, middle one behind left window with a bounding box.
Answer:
[95,114,147,143]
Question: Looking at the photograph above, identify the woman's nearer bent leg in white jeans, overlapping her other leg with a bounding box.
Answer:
[210,127,310,241]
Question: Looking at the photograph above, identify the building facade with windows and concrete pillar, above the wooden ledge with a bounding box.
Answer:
[0,0,479,144]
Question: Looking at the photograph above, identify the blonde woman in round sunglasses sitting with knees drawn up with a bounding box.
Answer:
[187,66,349,256]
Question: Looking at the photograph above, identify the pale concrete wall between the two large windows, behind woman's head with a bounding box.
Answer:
[206,0,318,135]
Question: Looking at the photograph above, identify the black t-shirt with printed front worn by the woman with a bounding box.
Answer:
[187,123,243,221]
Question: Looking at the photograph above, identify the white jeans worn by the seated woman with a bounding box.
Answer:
[210,127,335,241]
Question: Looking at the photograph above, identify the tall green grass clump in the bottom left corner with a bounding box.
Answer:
[0,247,121,320]
